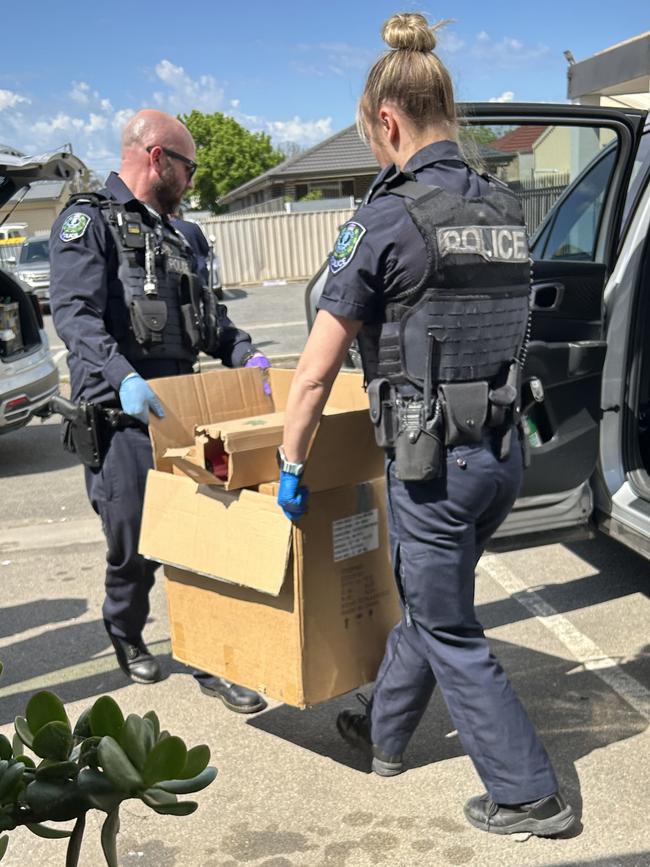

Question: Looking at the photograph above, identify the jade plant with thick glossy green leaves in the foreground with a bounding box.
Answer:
[0,666,217,867]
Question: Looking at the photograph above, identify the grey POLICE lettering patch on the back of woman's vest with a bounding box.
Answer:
[436,226,529,262]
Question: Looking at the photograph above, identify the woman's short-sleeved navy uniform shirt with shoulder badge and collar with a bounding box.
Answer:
[318,141,489,325]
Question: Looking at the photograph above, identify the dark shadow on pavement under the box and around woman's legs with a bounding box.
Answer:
[248,641,650,836]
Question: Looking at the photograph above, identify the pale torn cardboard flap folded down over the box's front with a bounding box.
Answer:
[139,468,291,596]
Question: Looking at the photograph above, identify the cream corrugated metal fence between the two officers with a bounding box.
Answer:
[200,208,354,286]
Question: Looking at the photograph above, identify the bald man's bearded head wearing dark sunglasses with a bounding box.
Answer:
[119,108,196,214]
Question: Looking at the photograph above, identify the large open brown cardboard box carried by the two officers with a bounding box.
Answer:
[140,370,399,707]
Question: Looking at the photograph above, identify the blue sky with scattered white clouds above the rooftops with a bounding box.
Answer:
[0,0,650,175]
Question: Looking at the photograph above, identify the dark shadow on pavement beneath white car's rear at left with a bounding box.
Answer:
[0,423,80,479]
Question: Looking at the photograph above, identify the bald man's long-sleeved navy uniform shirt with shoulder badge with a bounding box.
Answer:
[50,172,253,402]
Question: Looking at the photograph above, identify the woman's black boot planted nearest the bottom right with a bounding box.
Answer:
[465,792,576,837]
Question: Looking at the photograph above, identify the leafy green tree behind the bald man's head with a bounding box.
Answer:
[180,110,285,211]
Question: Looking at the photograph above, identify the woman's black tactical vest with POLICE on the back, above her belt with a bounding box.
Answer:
[359,176,530,390]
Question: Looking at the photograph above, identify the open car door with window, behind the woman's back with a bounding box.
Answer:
[461,103,645,537]
